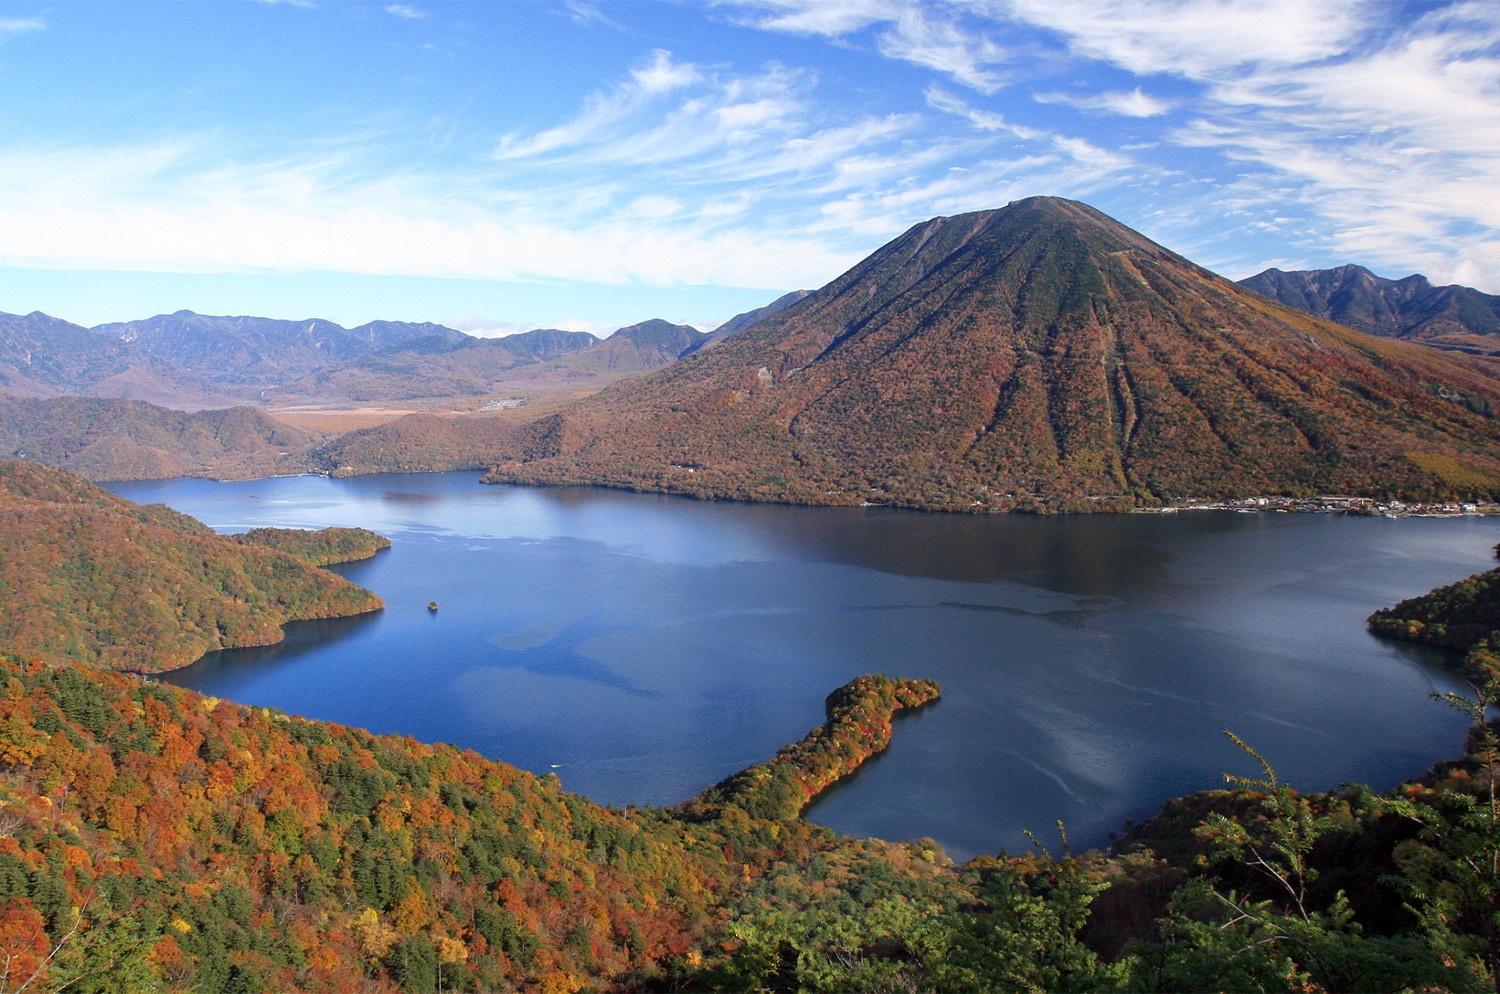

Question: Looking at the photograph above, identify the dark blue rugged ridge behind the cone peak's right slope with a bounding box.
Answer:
[1239,265,1500,355]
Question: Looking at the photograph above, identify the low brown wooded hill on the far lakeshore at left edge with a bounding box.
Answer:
[0,396,318,480]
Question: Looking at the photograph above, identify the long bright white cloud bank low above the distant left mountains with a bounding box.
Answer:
[0,139,854,288]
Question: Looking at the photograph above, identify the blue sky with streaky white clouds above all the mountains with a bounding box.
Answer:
[0,0,1500,334]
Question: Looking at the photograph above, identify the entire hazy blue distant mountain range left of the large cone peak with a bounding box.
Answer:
[0,310,707,408]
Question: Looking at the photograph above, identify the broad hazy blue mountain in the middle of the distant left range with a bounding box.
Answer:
[92,310,470,394]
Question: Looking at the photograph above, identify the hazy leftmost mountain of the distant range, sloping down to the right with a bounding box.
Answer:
[0,310,224,406]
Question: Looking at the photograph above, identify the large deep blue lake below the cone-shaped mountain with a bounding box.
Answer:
[111,474,1500,859]
